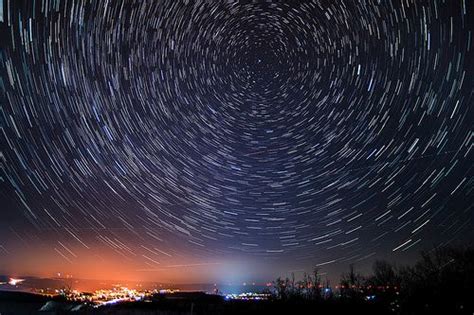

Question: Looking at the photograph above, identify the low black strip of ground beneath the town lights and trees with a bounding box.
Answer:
[0,292,473,315]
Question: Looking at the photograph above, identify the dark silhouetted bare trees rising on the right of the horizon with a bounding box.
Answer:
[272,247,474,314]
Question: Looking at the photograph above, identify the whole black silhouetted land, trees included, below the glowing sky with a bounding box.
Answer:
[0,247,474,315]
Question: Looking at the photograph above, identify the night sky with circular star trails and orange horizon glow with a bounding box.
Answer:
[0,0,474,282]
